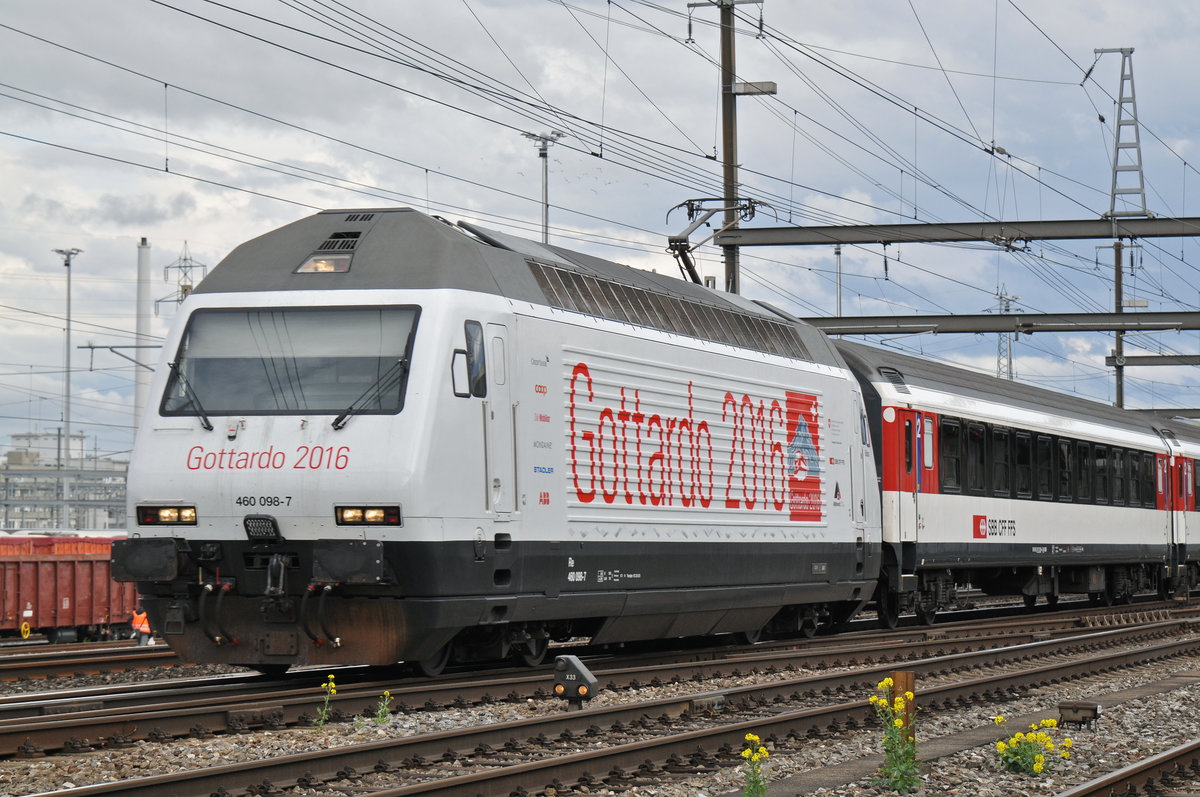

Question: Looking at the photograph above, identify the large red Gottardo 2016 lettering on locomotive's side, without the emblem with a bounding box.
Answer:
[569,362,788,511]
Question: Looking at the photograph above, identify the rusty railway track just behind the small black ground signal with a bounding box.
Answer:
[0,612,1187,757]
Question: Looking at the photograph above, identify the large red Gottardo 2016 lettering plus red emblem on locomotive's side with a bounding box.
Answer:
[568,362,823,522]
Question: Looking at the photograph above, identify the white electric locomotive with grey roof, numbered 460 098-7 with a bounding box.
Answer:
[113,209,883,672]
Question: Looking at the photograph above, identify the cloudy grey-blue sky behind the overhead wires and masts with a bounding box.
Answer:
[0,0,1200,457]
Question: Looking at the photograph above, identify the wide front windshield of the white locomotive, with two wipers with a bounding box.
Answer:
[160,306,420,418]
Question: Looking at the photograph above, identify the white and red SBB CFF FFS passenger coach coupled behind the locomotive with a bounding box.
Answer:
[836,341,1176,624]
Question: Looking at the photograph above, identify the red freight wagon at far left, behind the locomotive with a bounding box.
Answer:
[0,535,137,642]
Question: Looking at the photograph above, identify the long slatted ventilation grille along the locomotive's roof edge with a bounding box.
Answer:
[527,260,811,360]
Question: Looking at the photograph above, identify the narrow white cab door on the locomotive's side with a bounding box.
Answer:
[484,324,516,520]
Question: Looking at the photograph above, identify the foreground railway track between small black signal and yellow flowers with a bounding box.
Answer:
[14,607,1200,795]
